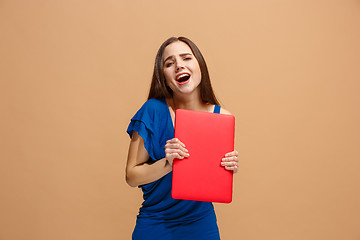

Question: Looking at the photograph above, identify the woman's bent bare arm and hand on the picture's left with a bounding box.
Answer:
[126,131,187,187]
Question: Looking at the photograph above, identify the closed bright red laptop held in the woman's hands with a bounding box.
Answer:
[171,109,235,203]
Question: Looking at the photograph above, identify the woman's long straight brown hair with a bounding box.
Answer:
[148,37,220,105]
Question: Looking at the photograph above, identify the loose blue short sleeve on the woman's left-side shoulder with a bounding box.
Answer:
[126,100,162,161]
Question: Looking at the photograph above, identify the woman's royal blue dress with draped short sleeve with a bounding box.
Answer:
[127,99,220,240]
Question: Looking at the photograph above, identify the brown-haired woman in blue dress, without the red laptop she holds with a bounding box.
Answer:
[126,37,238,240]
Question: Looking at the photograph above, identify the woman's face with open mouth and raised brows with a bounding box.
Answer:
[163,41,201,94]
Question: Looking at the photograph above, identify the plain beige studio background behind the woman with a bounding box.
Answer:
[0,0,360,240]
